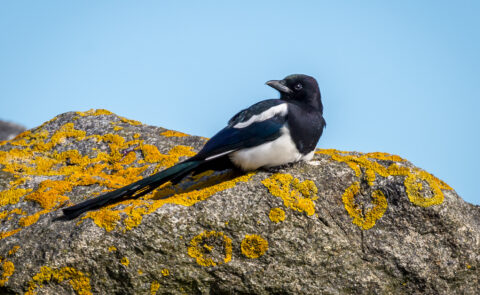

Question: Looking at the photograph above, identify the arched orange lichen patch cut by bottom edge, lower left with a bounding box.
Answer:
[25,266,92,295]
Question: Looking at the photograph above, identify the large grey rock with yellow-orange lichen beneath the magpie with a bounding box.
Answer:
[0,110,480,294]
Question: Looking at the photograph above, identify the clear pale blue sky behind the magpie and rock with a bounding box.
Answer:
[0,0,480,204]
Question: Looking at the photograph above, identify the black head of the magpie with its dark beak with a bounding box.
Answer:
[266,74,323,112]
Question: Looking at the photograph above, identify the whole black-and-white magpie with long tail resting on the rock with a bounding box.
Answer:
[63,74,326,219]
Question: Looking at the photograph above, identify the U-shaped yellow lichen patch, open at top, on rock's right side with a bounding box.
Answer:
[342,182,387,230]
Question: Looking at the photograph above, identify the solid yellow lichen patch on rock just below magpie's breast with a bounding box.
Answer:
[262,173,318,216]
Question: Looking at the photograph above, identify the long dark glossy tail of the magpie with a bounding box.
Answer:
[62,161,202,219]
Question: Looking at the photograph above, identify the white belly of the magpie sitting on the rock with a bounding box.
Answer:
[230,127,313,171]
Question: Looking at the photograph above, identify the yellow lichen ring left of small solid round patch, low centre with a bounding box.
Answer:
[188,231,232,266]
